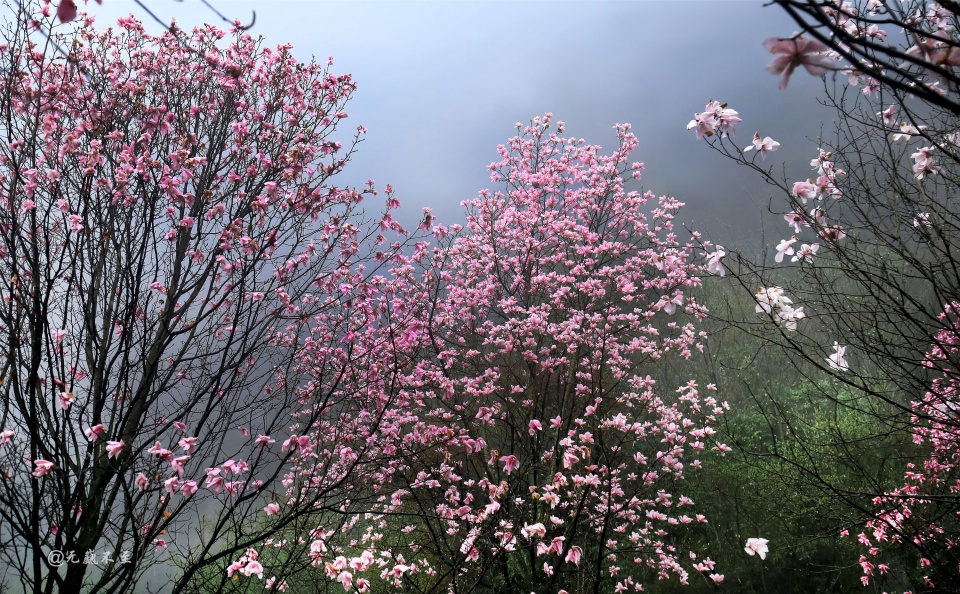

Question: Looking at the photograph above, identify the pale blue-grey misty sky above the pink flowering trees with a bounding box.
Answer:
[88,0,831,247]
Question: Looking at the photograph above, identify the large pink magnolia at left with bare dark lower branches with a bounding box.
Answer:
[0,5,424,592]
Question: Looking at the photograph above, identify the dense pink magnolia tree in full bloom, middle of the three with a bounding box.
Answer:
[300,114,725,592]
